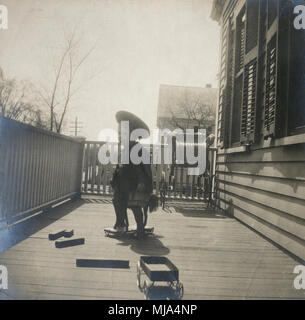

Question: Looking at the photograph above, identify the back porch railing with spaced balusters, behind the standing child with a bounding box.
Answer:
[82,141,216,200]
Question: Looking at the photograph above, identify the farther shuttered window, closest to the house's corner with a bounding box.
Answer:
[223,0,260,147]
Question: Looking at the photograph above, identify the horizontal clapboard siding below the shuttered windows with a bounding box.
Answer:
[216,144,305,260]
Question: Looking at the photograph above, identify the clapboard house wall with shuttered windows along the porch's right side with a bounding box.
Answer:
[212,0,305,260]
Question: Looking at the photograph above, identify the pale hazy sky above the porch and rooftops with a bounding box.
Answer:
[0,0,219,140]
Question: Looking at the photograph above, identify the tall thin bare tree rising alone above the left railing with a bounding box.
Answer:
[38,31,95,133]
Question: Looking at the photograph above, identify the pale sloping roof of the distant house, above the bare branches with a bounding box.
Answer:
[158,84,218,119]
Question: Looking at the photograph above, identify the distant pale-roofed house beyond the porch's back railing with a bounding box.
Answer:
[157,84,218,132]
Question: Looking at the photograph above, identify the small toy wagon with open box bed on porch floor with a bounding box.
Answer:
[137,256,183,300]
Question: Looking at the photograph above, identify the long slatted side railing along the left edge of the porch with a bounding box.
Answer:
[0,117,83,224]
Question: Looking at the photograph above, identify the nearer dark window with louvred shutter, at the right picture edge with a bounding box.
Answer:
[263,0,305,139]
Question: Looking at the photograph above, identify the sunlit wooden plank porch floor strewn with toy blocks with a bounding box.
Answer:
[0,199,305,299]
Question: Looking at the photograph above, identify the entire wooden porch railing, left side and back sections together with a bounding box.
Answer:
[0,117,216,224]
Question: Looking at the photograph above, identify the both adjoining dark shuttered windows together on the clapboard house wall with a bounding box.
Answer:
[219,0,305,148]
